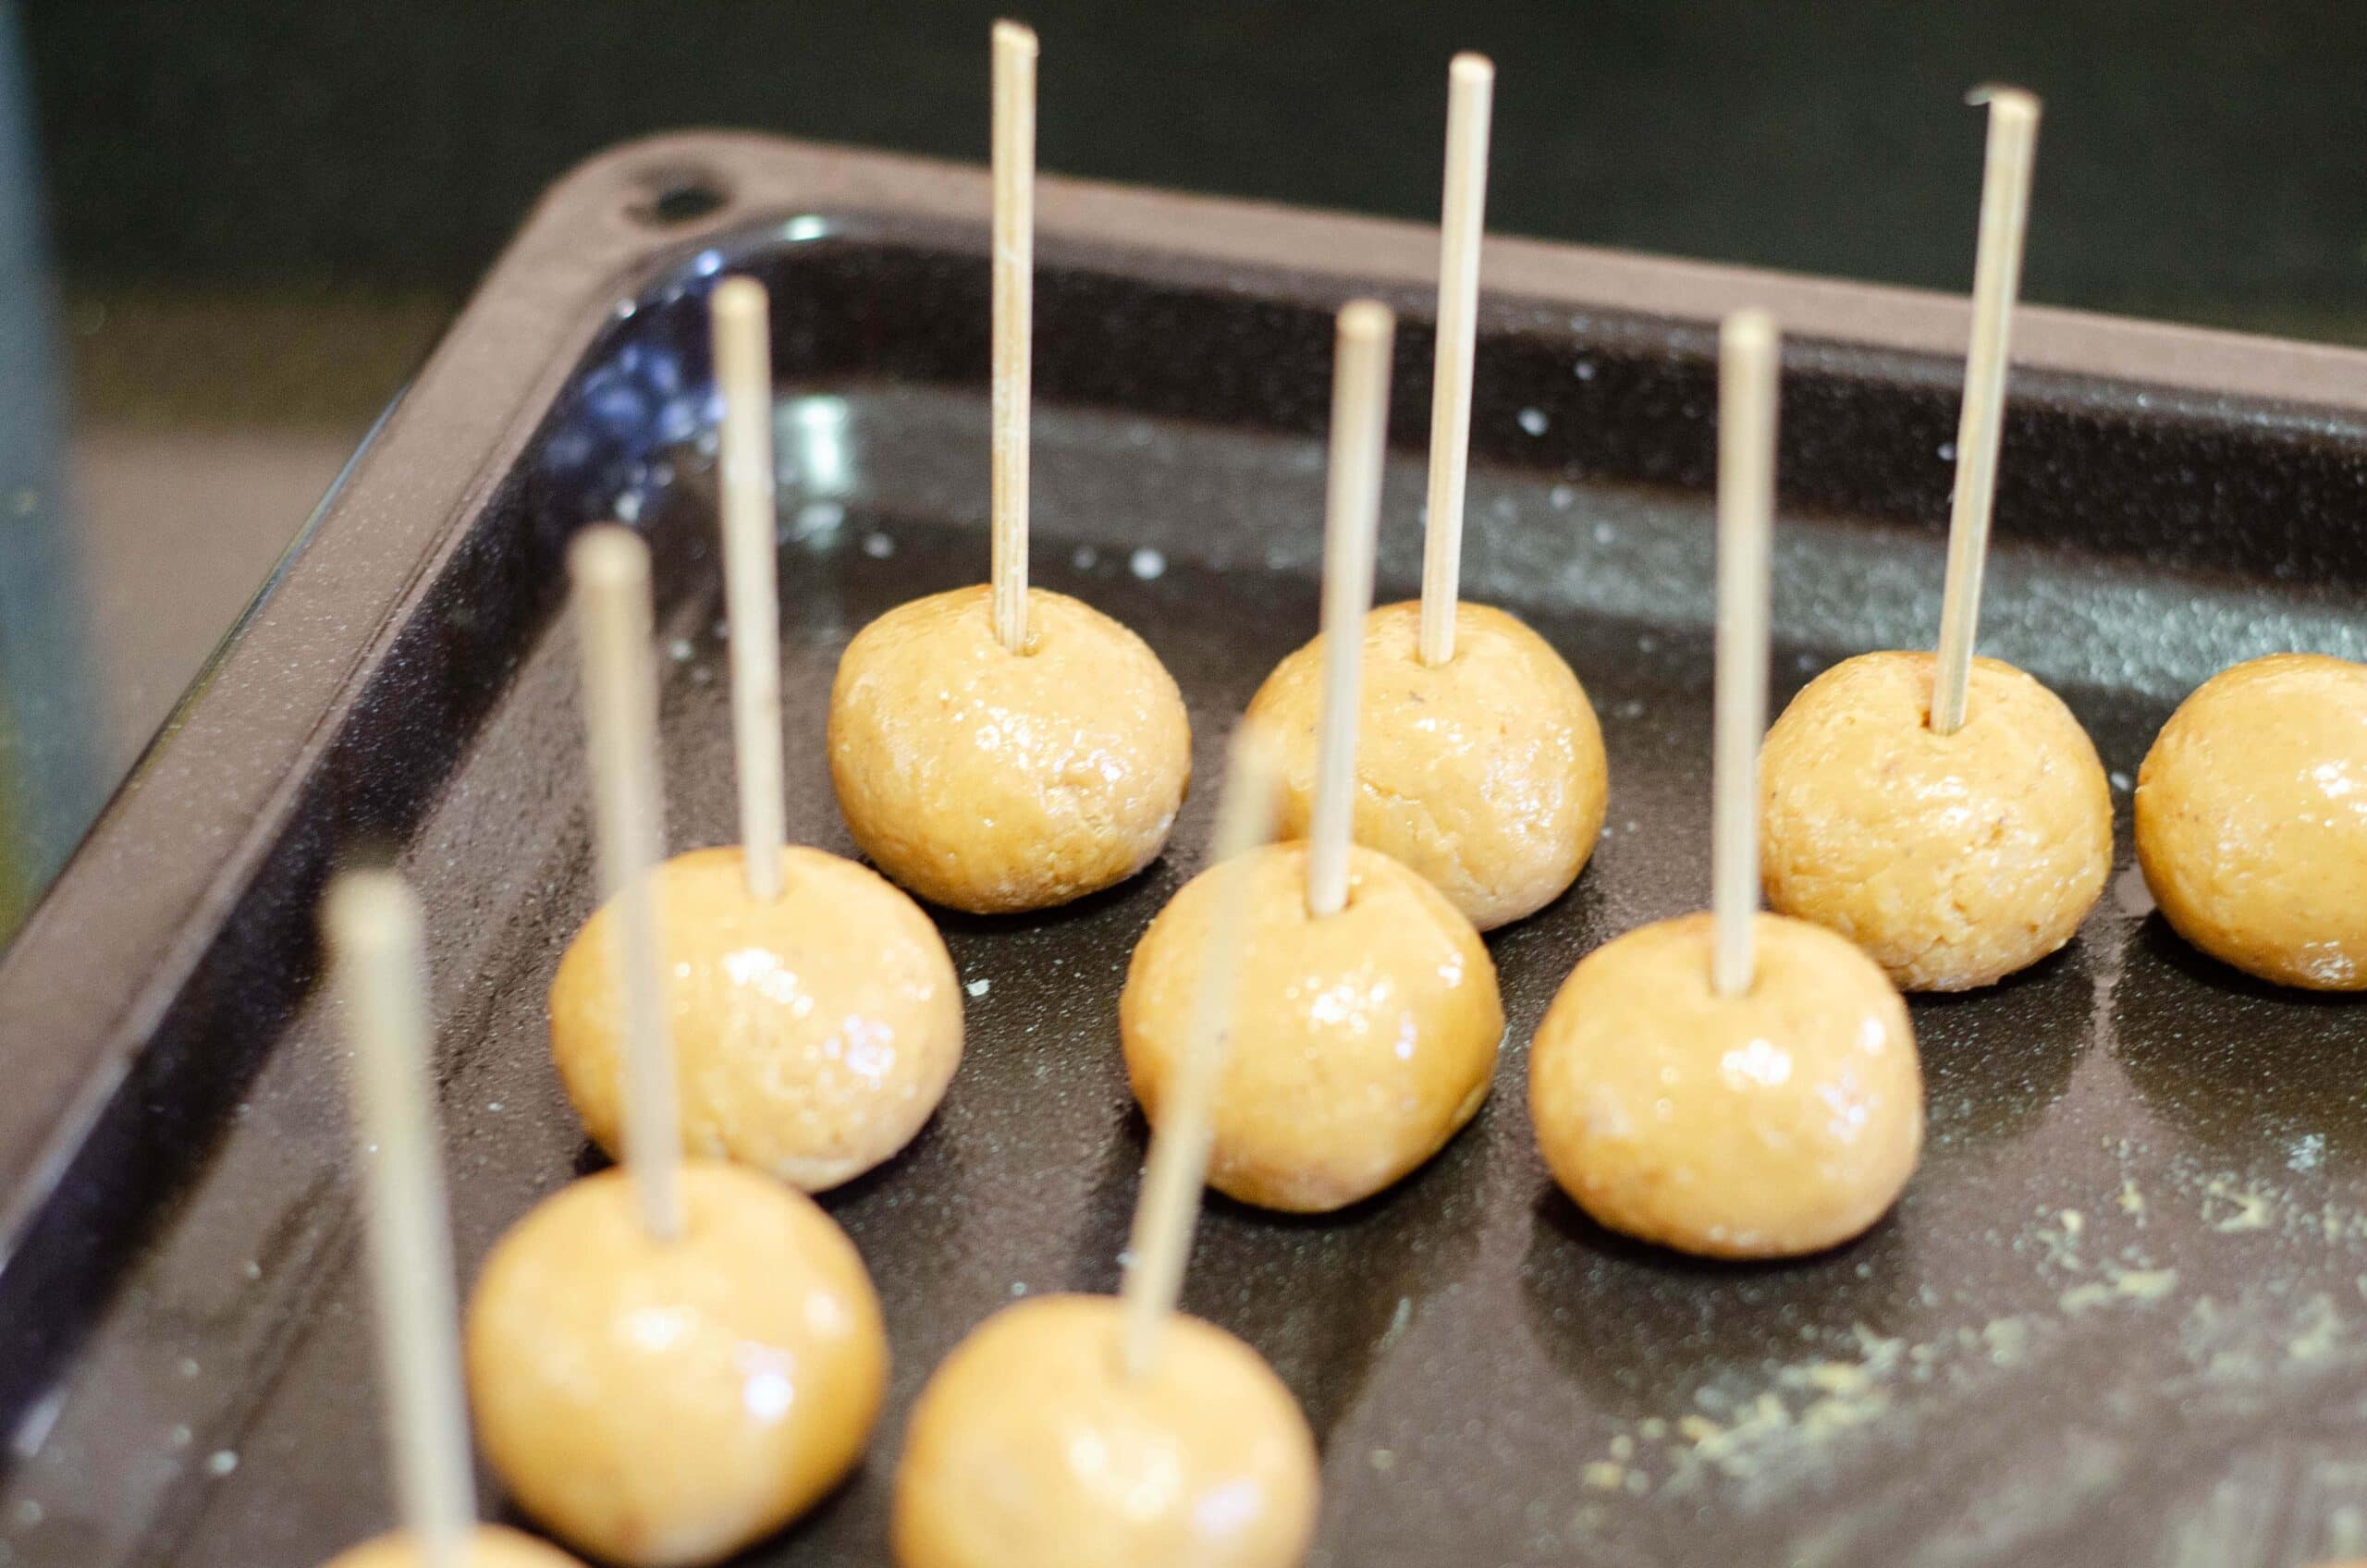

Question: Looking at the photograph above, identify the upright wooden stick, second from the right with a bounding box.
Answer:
[1709,311,1783,998]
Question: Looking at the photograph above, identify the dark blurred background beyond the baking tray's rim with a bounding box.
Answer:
[0,0,2367,940]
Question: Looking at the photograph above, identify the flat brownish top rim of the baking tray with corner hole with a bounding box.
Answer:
[0,130,2367,1373]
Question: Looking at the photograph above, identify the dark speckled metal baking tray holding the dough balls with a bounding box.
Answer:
[0,135,2367,1568]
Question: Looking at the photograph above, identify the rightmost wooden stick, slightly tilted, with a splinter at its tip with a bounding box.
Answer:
[1932,88,2038,734]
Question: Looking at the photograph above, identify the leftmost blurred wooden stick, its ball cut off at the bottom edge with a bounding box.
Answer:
[322,872,476,1568]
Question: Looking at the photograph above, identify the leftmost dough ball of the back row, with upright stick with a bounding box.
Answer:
[831,587,1191,914]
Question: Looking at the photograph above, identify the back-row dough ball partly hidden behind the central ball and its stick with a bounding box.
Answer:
[1250,604,1610,931]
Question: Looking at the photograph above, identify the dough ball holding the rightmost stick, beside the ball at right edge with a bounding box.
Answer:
[1759,654,2112,990]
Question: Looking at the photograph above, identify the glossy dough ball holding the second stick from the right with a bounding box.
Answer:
[1529,914,1922,1257]
